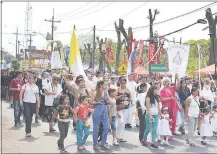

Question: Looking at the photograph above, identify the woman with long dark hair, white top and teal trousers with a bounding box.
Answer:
[142,87,161,148]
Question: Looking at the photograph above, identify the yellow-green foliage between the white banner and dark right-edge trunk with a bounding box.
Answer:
[187,39,210,74]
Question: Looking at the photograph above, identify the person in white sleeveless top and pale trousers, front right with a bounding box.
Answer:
[185,87,200,146]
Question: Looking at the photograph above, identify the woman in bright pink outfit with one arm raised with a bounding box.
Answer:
[160,73,180,134]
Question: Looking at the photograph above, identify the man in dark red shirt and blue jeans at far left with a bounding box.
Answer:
[9,71,24,127]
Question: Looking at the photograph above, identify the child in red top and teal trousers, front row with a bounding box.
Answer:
[75,95,93,150]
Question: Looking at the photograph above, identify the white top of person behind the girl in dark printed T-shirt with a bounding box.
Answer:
[45,83,63,106]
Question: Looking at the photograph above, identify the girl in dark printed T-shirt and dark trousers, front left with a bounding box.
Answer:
[49,95,74,151]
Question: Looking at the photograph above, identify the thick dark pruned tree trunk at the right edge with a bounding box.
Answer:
[206,8,217,65]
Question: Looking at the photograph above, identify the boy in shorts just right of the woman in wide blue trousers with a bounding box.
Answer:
[108,88,119,146]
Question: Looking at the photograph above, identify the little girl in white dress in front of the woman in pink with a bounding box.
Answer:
[159,107,172,145]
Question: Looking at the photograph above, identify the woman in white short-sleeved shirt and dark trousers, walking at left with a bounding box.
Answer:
[20,75,40,137]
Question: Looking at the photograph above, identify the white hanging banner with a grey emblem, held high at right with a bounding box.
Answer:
[167,44,190,78]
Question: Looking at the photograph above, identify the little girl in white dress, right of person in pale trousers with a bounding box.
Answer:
[200,107,213,145]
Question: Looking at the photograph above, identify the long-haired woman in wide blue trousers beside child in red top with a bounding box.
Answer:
[91,81,110,150]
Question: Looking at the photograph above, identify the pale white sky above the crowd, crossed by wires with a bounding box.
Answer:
[2,2,217,55]
